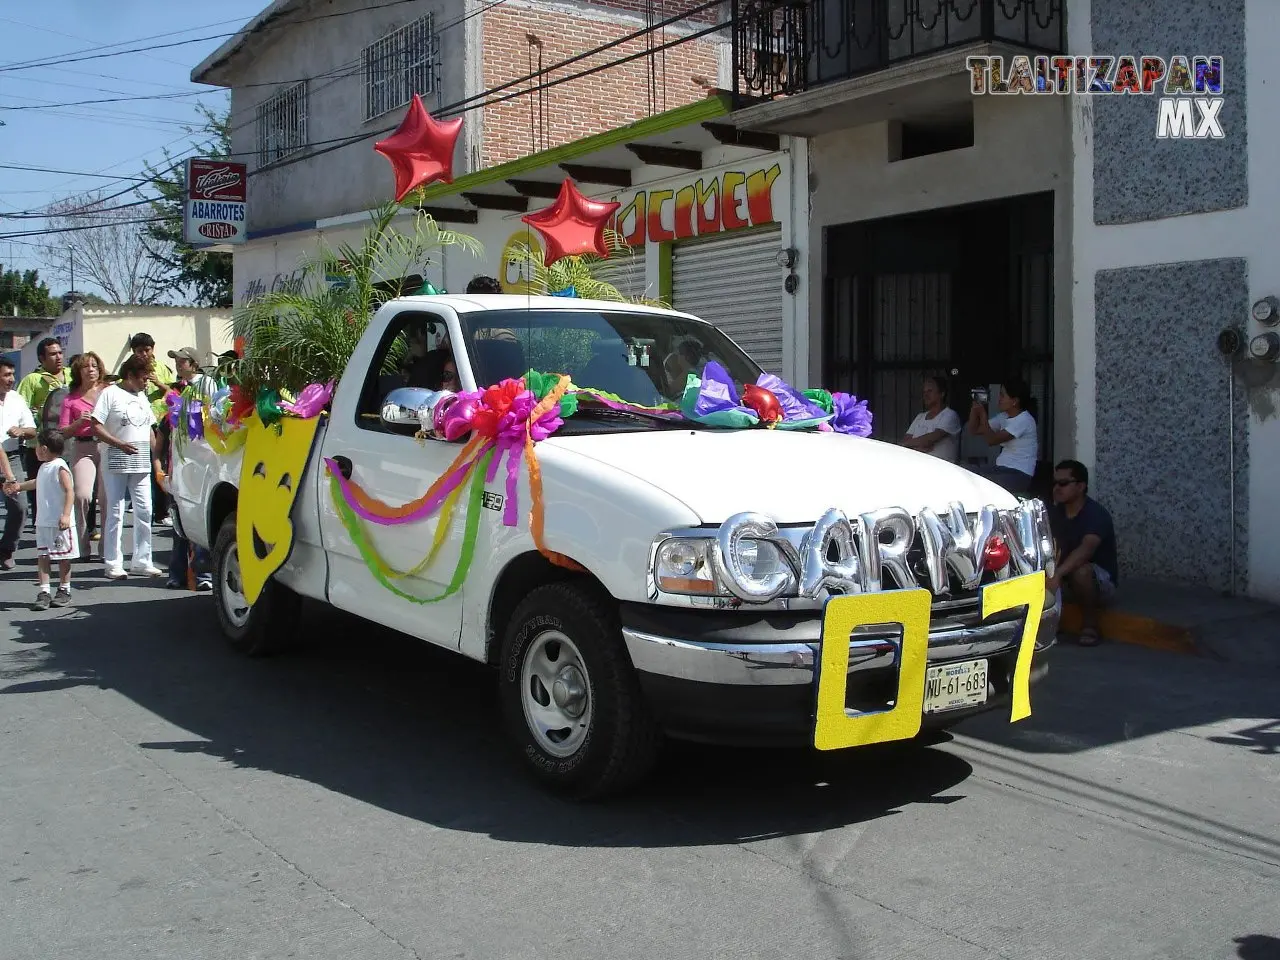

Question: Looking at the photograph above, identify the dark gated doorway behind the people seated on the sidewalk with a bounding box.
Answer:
[822,192,1053,471]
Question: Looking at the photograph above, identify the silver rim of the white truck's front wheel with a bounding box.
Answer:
[520,630,594,756]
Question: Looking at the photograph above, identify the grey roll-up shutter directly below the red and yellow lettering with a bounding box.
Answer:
[671,228,785,376]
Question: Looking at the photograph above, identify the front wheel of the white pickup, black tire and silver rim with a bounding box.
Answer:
[499,584,662,800]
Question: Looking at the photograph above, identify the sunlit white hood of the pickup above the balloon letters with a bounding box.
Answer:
[540,430,1018,524]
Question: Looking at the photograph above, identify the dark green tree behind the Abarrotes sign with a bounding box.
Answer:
[145,104,233,307]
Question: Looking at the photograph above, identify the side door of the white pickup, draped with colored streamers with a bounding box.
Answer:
[319,310,463,648]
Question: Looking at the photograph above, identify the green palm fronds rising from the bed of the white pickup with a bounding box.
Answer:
[227,204,483,393]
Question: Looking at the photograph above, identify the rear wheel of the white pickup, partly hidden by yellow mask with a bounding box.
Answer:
[214,511,302,657]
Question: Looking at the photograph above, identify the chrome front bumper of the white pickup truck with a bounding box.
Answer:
[622,602,1062,686]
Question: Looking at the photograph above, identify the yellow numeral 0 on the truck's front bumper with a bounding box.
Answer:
[813,590,933,750]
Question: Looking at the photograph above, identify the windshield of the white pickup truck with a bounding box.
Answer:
[460,307,762,407]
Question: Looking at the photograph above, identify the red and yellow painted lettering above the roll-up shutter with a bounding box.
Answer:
[613,161,786,247]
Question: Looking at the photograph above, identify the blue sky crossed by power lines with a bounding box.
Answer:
[0,0,269,296]
